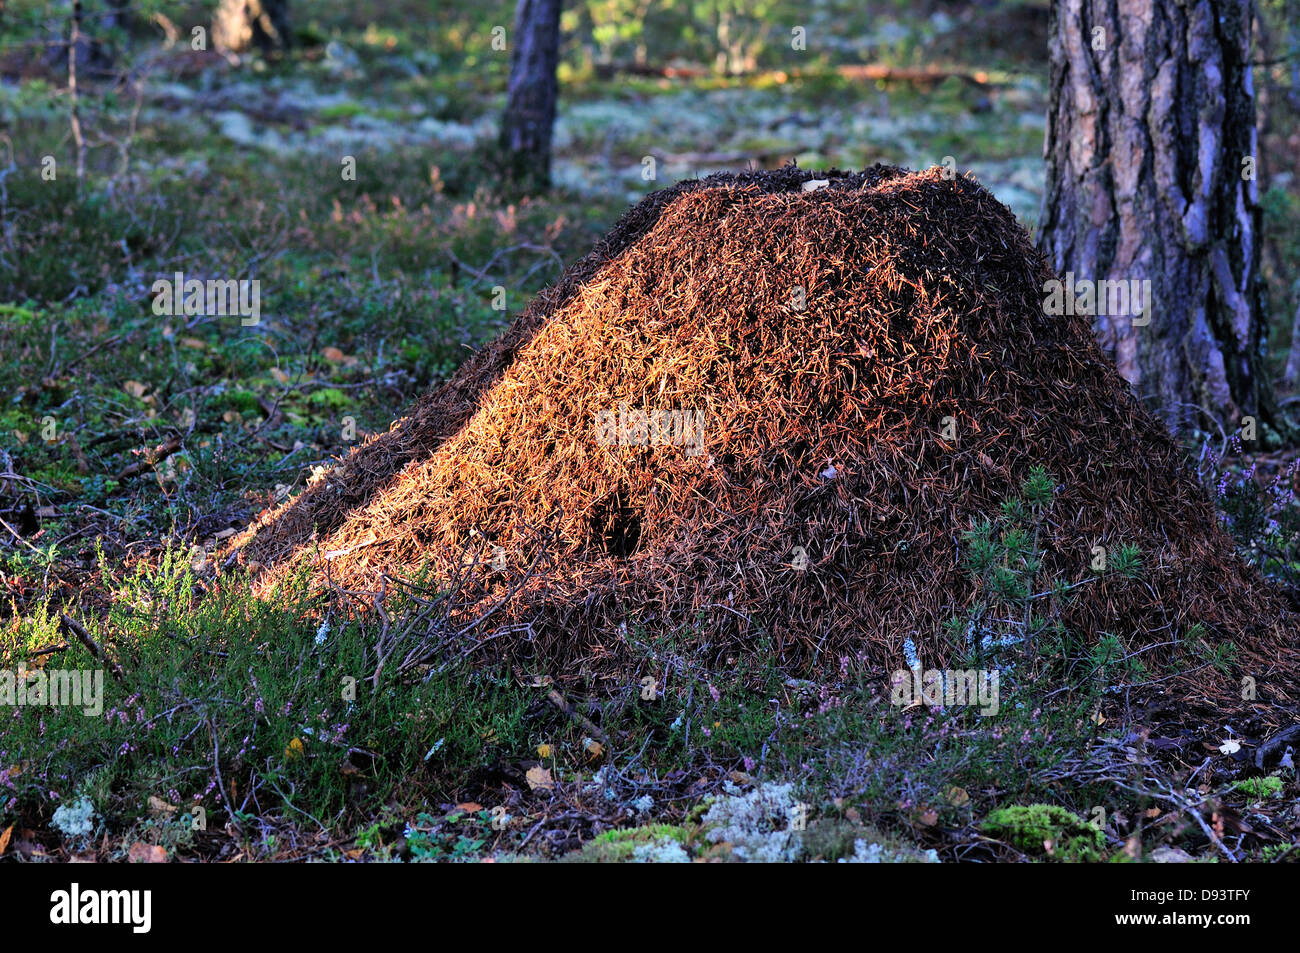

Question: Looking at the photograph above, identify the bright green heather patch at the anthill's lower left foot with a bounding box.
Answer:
[0,550,530,842]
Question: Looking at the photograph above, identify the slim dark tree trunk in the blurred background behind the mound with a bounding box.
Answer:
[501,0,560,190]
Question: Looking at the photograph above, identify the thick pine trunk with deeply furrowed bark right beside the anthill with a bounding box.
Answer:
[1039,0,1288,433]
